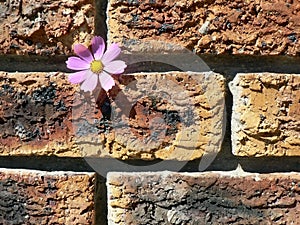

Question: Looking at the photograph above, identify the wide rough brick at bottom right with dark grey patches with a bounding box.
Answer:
[107,169,300,225]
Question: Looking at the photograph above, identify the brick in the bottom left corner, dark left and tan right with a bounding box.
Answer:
[0,169,95,225]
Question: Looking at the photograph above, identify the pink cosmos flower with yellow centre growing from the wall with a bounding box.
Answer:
[66,36,126,91]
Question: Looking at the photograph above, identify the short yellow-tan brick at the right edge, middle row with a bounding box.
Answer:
[230,73,300,156]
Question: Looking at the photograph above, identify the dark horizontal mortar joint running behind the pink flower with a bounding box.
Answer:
[0,53,300,75]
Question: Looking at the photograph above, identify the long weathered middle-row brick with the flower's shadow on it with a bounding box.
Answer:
[0,72,224,160]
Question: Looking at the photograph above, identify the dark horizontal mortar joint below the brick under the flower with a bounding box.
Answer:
[0,155,300,176]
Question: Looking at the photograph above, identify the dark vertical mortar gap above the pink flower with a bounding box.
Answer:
[94,0,108,41]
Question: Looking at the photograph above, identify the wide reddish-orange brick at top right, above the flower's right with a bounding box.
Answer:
[108,0,300,55]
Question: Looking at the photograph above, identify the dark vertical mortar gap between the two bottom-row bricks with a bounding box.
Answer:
[94,173,108,225]
